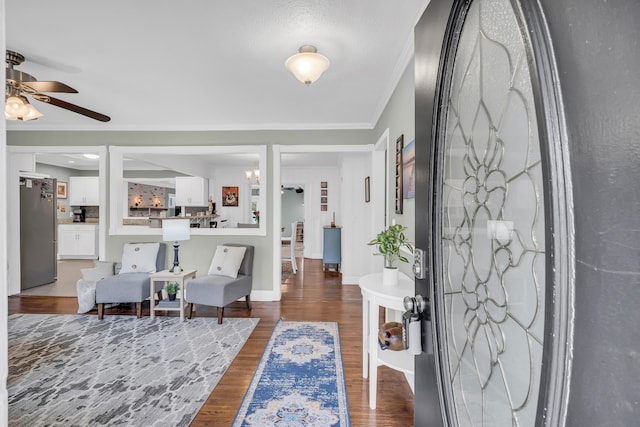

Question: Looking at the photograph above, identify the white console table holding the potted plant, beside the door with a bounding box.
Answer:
[359,273,415,409]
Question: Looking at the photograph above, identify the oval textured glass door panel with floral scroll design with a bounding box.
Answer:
[432,0,570,427]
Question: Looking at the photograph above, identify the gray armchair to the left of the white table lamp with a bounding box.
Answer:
[96,242,167,319]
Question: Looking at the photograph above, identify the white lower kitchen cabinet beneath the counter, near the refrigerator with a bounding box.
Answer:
[58,224,98,259]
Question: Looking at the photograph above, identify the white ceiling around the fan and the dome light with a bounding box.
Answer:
[5,0,428,130]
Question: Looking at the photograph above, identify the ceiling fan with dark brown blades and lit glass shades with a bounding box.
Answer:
[5,50,111,122]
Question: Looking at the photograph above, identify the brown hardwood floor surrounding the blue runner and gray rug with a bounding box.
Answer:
[9,259,414,427]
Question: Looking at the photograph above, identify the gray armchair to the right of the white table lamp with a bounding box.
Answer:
[185,243,254,324]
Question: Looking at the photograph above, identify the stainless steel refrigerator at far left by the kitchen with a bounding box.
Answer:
[20,177,58,289]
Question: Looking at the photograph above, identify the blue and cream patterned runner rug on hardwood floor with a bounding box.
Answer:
[233,321,350,427]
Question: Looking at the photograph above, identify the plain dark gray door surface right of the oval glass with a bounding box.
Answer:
[541,0,640,426]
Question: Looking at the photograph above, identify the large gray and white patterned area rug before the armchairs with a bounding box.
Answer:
[7,314,259,427]
